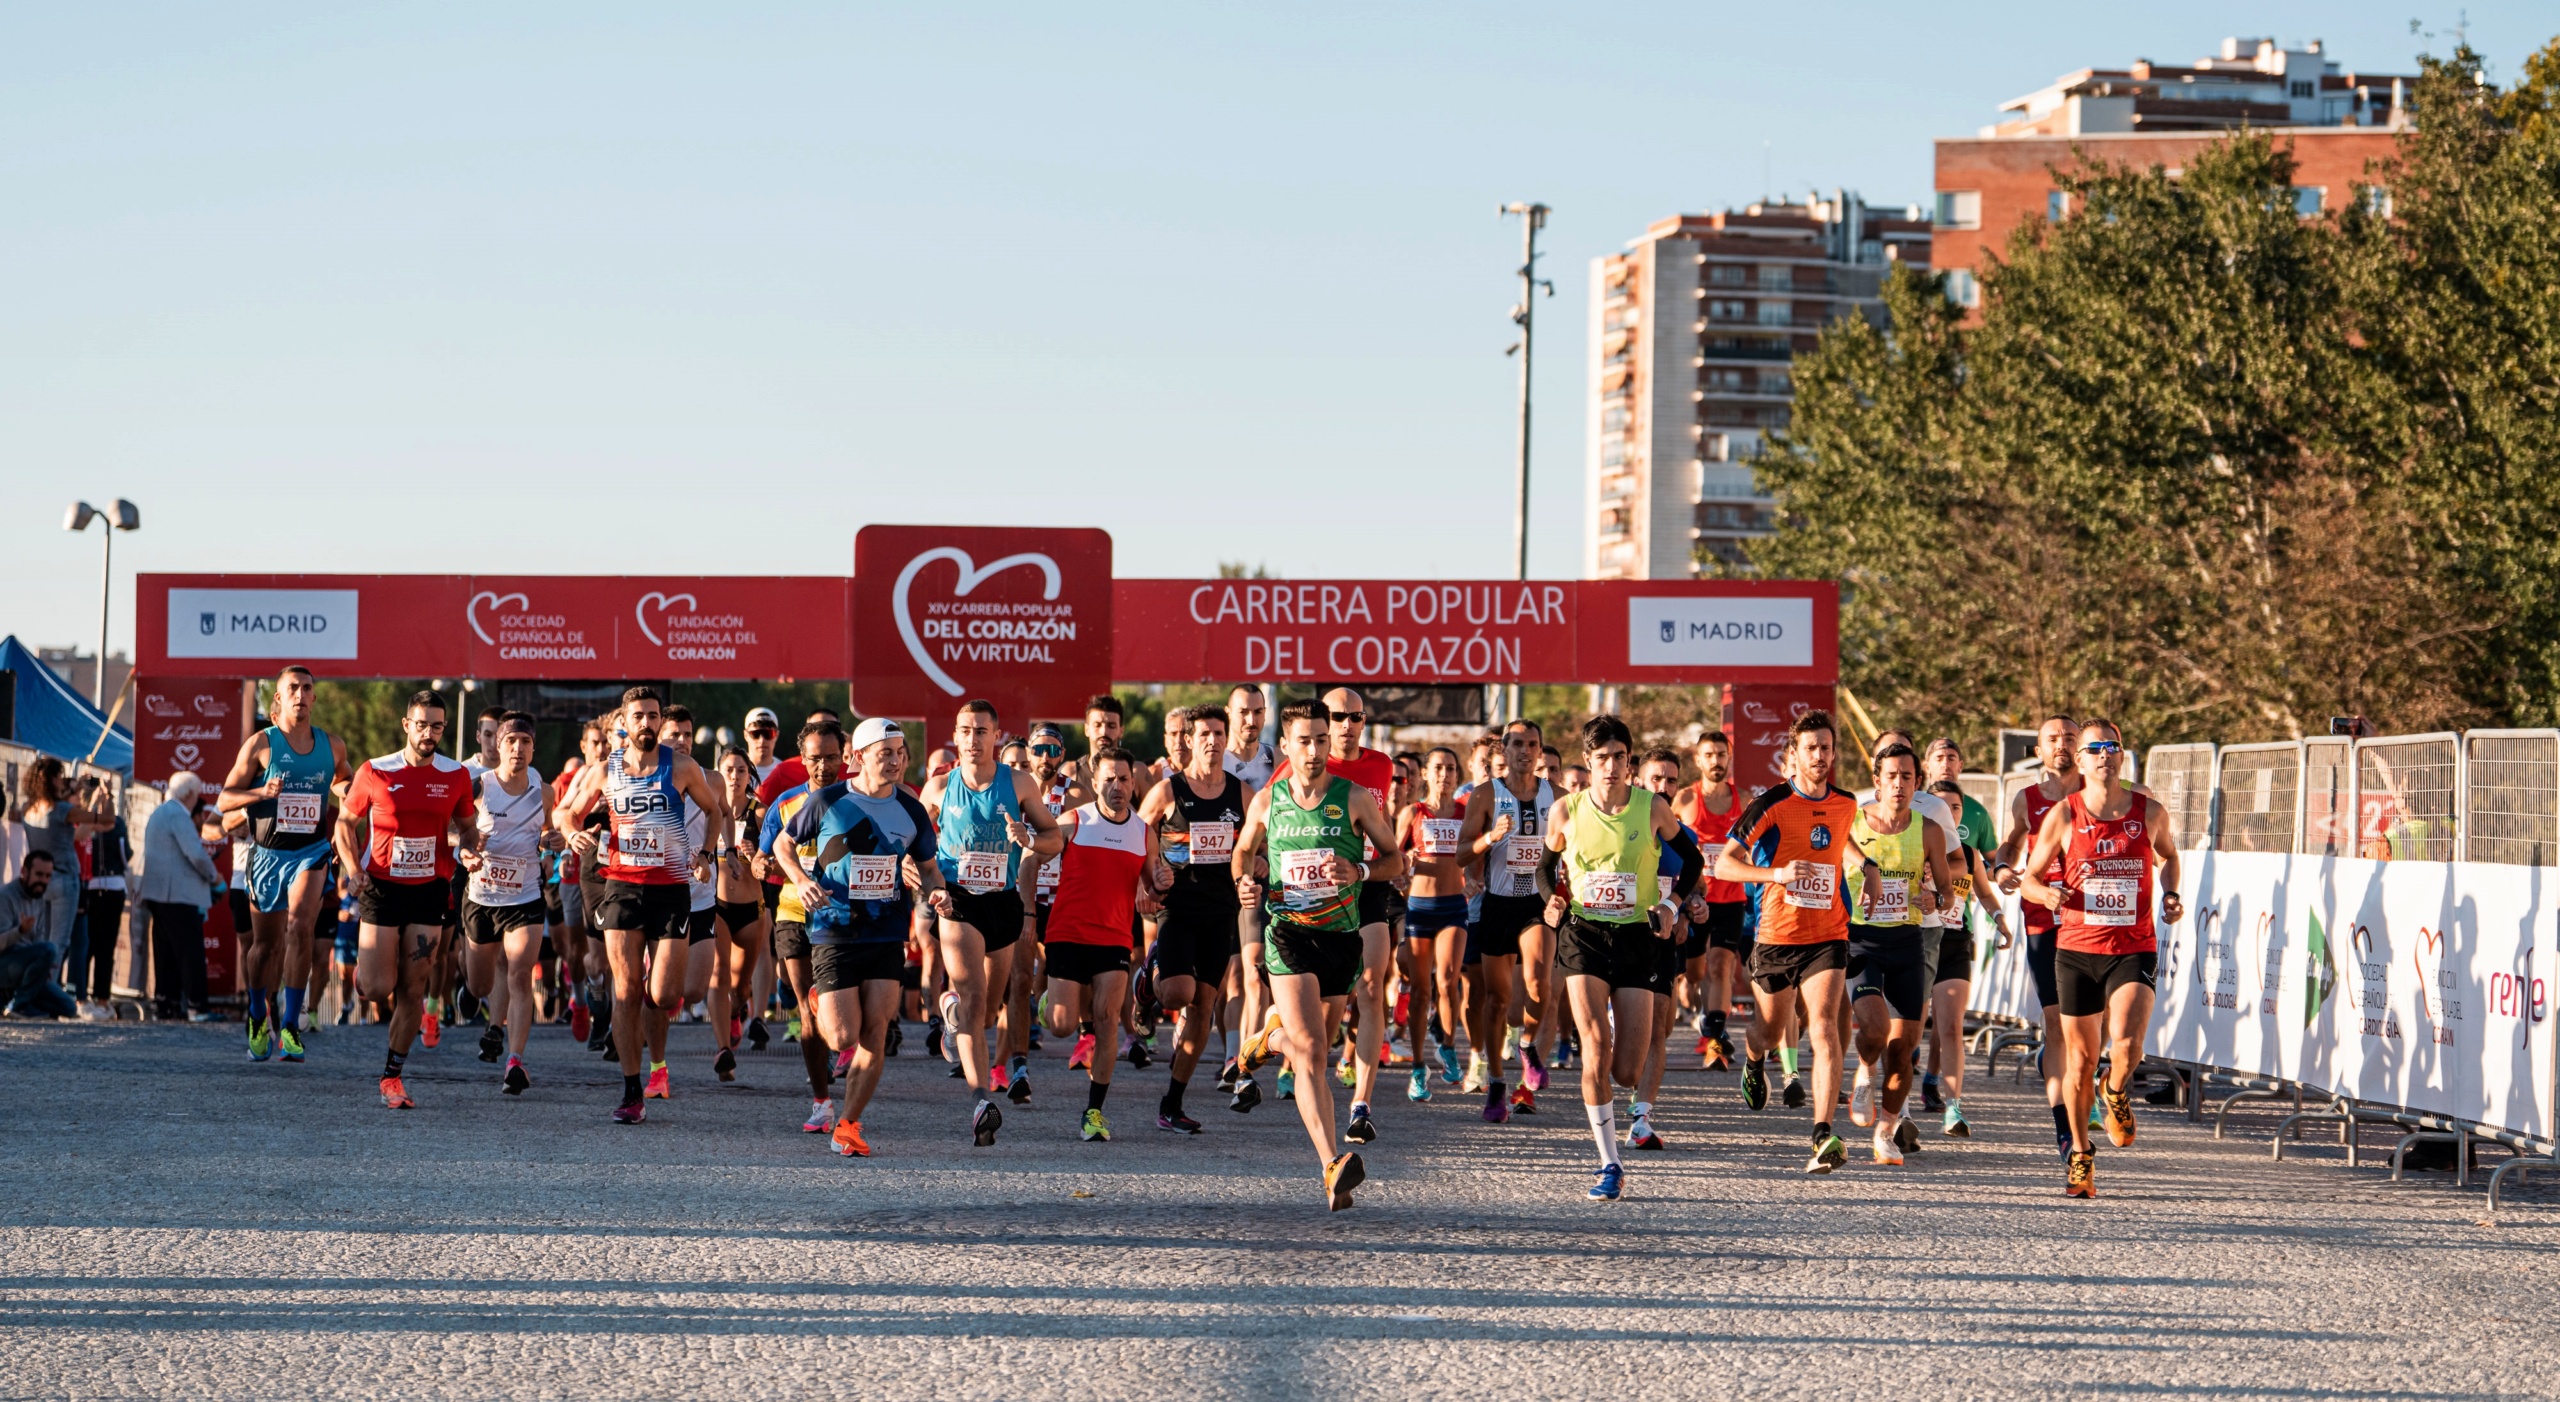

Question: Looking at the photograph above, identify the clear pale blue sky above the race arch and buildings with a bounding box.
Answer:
[0,3,2560,650]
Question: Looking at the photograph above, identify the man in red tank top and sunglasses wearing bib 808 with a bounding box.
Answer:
[2025,721,2186,1197]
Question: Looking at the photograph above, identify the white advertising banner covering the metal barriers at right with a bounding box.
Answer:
[2148,852,2560,1136]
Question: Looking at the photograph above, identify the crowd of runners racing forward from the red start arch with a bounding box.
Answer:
[218,668,2181,1210]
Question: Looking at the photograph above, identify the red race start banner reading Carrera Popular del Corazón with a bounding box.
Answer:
[133,524,1838,775]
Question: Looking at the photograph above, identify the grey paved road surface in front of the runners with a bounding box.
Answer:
[0,1023,2560,1402]
